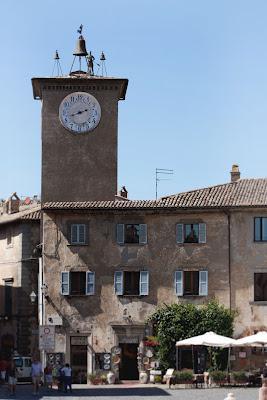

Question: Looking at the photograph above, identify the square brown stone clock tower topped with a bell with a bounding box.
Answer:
[32,30,128,202]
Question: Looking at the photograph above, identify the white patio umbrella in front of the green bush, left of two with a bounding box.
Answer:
[176,332,236,347]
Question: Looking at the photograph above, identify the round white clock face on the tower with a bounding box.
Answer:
[59,92,101,134]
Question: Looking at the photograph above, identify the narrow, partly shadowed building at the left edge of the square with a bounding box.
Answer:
[0,194,40,358]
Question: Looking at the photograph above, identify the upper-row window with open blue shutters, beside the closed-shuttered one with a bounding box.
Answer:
[117,224,147,244]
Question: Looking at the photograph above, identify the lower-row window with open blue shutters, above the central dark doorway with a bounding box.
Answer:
[114,271,149,296]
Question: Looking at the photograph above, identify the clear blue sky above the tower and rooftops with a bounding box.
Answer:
[0,0,267,199]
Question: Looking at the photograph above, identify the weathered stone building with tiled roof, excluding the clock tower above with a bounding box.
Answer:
[39,179,267,379]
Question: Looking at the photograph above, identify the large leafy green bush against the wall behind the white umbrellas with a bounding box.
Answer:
[148,300,235,369]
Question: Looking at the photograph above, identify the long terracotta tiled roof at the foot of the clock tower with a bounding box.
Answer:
[43,178,267,210]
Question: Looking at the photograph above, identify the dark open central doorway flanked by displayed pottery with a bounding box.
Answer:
[119,343,139,380]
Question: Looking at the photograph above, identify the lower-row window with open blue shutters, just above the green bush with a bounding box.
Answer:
[174,271,208,296]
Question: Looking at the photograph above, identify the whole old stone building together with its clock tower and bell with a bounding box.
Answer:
[25,31,267,381]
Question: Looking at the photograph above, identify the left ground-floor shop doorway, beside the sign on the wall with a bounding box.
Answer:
[70,336,87,383]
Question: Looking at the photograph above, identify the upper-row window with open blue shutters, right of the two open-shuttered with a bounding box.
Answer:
[176,223,206,243]
